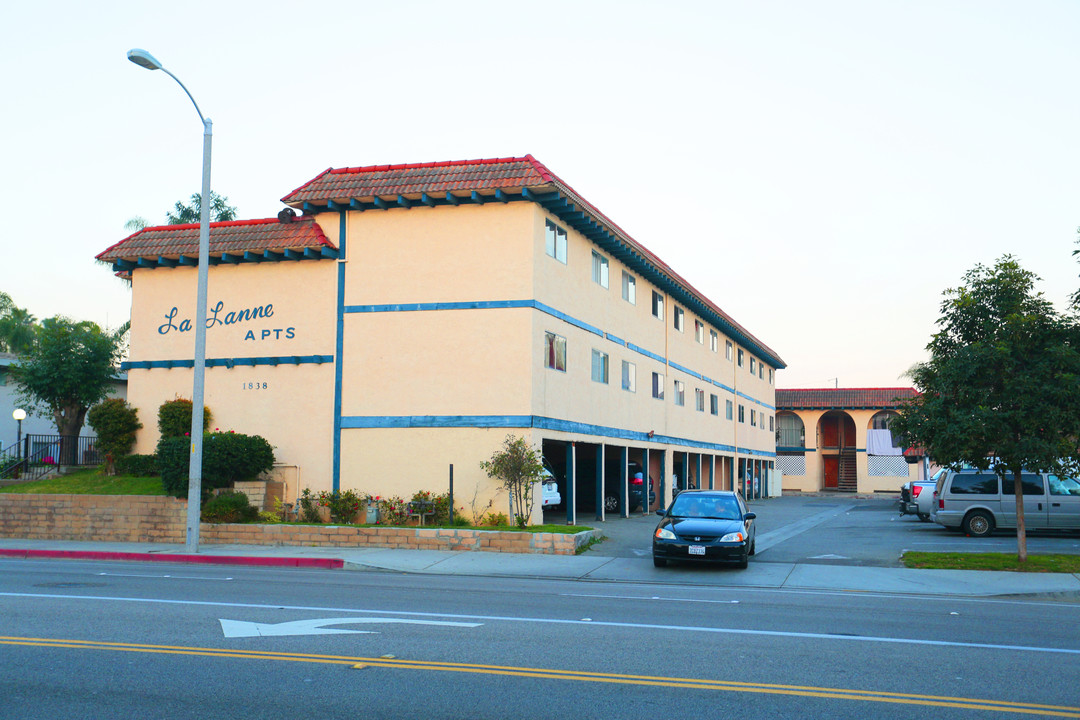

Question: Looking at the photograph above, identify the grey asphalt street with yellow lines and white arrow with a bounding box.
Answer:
[0,557,1080,720]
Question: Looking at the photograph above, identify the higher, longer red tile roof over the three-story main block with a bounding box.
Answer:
[282,154,786,368]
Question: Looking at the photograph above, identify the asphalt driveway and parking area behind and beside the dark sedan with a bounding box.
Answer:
[581,493,1080,568]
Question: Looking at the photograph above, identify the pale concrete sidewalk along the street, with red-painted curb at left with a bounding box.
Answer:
[0,537,1080,599]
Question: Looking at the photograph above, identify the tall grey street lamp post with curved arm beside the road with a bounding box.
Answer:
[127,49,213,553]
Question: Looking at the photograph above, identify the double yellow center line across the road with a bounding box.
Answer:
[0,636,1080,718]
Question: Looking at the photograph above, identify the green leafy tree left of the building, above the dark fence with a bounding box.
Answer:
[12,316,127,463]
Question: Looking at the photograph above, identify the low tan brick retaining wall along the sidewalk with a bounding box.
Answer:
[0,493,600,555]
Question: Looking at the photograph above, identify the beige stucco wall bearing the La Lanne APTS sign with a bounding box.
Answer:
[127,260,336,487]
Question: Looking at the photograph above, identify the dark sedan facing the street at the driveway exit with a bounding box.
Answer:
[652,490,757,568]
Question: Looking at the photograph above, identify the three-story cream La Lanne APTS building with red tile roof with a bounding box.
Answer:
[98,155,784,522]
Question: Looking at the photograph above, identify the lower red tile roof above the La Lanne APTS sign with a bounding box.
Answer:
[97,217,335,262]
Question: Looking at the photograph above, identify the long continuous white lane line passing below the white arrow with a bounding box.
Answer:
[0,593,1080,656]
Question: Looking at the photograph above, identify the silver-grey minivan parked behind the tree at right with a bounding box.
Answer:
[932,470,1080,538]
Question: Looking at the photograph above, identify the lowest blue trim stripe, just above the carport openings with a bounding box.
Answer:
[341,415,775,458]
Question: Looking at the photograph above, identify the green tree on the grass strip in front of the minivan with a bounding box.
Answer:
[891,255,1080,562]
